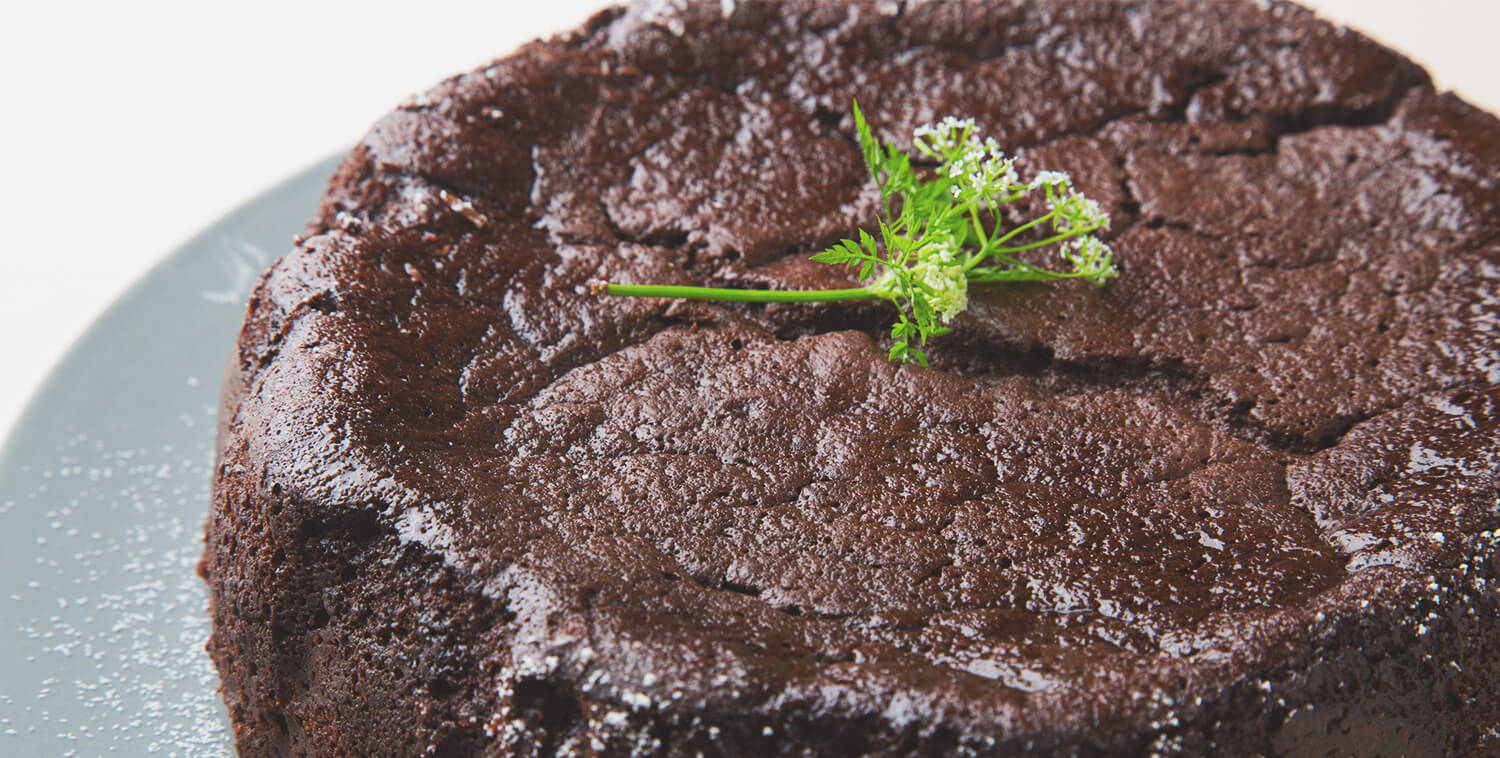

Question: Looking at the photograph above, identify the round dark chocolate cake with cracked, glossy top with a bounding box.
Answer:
[203,0,1500,756]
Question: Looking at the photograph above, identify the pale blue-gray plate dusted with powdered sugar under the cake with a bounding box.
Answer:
[0,159,335,756]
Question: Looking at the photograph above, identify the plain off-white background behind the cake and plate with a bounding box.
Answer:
[0,0,1500,438]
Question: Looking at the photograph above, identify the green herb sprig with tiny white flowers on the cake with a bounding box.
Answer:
[590,102,1118,366]
